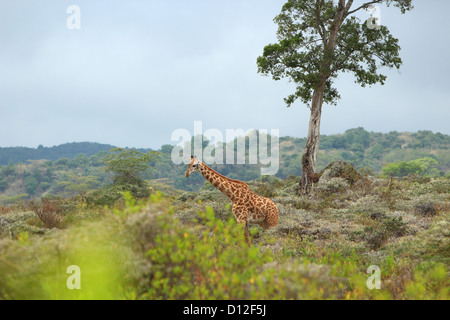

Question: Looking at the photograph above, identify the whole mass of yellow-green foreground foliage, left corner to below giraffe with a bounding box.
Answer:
[0,193,274,299]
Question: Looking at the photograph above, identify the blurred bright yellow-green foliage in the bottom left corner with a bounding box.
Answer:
[0,220,130,300]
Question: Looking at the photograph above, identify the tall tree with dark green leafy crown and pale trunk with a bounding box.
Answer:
[257,0,413,194]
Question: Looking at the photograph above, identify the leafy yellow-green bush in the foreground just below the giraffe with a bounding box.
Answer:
[127,201,273,299]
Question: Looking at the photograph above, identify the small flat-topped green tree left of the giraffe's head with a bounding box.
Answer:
[104,148,159,198]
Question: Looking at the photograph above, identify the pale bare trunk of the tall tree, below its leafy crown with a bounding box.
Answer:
[299,81,325,194]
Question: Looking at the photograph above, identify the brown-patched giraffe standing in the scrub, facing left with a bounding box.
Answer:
[186,156,278,245]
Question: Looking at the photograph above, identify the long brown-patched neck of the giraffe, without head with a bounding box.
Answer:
[200,163,248,202]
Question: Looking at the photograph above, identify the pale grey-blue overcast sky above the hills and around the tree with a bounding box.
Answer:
[0,0,450,149]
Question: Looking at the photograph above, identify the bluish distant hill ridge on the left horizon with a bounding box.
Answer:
[0,142,118,165]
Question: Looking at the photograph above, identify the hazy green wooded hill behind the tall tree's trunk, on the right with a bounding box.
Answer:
[280,127,450,177]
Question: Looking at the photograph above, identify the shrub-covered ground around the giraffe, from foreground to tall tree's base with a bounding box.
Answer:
[0,170,450,300]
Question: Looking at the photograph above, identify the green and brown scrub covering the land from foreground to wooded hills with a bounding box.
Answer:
[0,129,450,300]
